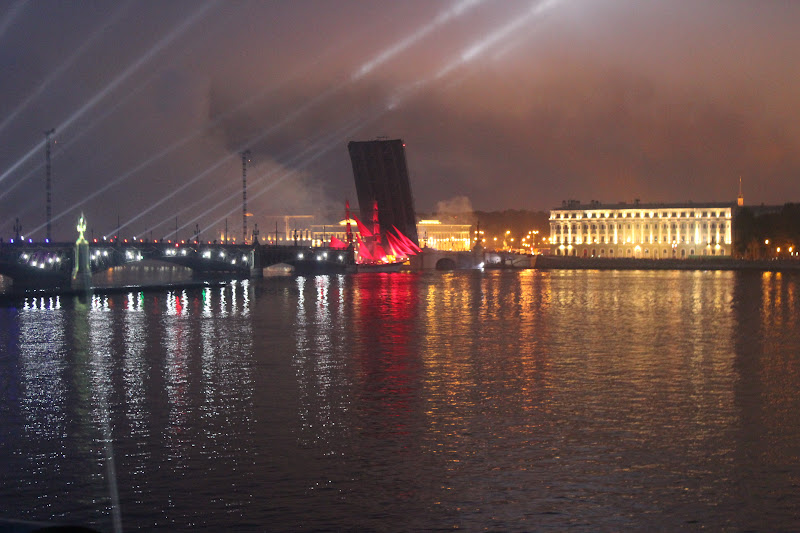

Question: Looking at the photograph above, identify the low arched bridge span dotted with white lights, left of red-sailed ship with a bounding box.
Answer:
[0,240,354,288]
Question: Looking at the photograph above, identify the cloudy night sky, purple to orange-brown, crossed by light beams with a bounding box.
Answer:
[0,0,800,240]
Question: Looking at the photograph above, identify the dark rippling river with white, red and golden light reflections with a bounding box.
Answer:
[0,270,800,531]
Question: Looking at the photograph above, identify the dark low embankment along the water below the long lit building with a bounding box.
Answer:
[533,255,800,272]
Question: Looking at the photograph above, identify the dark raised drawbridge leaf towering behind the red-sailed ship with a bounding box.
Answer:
[347,139,419,245]
